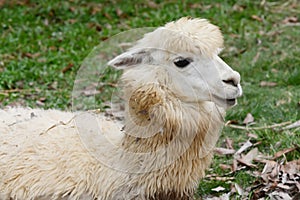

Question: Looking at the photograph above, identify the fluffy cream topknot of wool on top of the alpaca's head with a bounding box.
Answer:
[134,17,223,57]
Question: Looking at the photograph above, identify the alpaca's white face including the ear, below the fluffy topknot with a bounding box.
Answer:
[108,48,242,108]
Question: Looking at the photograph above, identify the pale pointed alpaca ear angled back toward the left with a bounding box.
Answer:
[107,49,153,69]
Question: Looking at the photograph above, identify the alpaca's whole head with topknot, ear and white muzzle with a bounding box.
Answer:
[108,17,242,108]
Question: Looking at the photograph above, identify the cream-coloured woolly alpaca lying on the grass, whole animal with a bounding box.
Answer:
[0,17,242,200]
